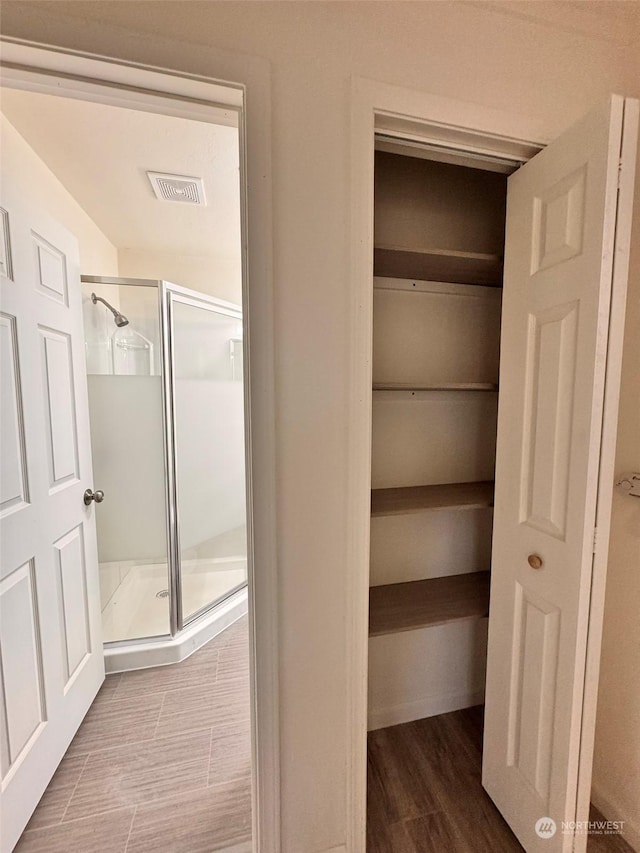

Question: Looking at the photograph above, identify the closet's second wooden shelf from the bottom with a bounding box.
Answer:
[371,480,493,517]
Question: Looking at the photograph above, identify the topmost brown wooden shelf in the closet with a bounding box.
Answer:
[373,246,503,287]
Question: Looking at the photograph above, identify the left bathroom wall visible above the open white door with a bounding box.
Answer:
[0,115,118,275]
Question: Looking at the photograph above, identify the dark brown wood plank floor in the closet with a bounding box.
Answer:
[367,705,633,853]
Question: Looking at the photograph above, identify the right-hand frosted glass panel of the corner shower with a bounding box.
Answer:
[172,296,247,622]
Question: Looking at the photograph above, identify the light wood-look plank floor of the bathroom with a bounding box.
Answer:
[15,617,251,853]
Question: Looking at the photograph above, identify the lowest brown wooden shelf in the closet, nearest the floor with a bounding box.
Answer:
[369,572,489,637]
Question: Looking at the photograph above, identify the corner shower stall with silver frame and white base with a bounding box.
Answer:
[82,276,247,672]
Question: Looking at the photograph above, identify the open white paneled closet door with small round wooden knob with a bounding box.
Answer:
[483,96,638,853]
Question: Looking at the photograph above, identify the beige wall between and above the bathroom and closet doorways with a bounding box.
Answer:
[3,6,640,853]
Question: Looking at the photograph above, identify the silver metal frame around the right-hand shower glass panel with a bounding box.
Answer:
[162,279,250,637]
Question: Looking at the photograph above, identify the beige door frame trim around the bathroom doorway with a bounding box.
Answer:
[0,37,280,853]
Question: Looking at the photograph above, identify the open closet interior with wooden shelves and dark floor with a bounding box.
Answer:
[367,134,522,853]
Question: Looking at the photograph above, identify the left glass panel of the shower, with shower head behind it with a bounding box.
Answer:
[82,283,169,642]
